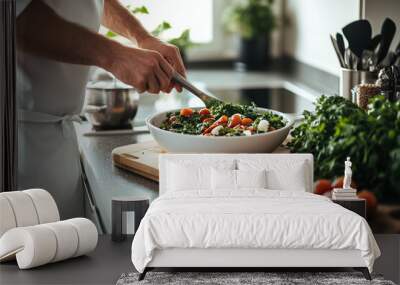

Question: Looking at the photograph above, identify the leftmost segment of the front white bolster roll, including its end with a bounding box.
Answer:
[0,225,57,269]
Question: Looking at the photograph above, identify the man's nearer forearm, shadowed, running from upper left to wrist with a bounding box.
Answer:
[17,1,122,69]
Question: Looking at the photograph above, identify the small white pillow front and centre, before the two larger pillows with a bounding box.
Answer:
[211,168,267,191]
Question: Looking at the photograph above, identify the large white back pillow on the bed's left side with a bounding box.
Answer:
[167,160,235,192]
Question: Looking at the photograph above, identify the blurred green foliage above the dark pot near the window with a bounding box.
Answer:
[224,0,276,39]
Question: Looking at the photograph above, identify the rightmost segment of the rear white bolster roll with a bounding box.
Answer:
[23,189,60,224]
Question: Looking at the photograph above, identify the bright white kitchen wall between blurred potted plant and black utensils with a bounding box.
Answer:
[283,0,360,75]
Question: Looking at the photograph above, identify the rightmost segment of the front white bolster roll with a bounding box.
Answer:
[65,218,98,257]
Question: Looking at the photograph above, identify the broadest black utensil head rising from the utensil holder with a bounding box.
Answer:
[342,19,372,58]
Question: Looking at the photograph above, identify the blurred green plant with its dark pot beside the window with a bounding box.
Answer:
[224,0,276,69]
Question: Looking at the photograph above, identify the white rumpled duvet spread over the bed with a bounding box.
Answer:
[132,190,380,272]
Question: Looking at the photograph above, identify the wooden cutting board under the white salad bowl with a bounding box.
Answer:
[112,140,289,182]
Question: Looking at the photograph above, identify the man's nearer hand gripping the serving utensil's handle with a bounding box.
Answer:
[106,45,174,94]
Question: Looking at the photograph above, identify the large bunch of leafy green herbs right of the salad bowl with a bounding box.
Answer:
[289,96,400,202]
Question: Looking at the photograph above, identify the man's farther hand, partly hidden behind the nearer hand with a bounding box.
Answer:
[137,36,186,92]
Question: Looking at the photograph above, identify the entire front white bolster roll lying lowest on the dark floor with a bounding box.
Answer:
[0,218,98,269]
